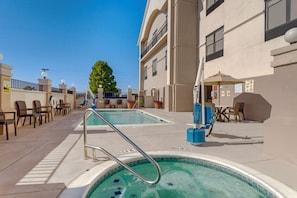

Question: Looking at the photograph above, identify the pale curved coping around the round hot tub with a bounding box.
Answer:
[61,151,297,198]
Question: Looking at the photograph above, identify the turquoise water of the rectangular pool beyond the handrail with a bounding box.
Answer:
[87,110,167,126]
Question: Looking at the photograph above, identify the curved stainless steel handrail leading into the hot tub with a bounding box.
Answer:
[83,108,161,184]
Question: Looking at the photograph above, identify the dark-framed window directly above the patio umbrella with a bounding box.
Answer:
[206,27,224,61]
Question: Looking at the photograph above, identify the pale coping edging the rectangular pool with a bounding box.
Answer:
[74,109,174,131]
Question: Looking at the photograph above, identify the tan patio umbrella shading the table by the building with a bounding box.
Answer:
[204,71,243,105]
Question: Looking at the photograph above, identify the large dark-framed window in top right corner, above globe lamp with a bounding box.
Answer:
[265,0,297,41]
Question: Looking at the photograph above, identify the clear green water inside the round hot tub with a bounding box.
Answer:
[87,158,274,198]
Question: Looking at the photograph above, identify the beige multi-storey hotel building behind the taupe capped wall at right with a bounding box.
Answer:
[138,0,297,111]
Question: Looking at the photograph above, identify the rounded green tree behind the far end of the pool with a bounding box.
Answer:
[89,61,118,93]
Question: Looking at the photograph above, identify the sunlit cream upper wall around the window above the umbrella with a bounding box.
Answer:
[199,0,286,79]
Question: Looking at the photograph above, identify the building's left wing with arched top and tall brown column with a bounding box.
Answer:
[139,0,198,111]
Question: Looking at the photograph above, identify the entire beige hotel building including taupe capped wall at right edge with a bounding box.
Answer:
[138,0,297,164]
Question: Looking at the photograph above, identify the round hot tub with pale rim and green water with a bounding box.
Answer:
[62,151,296,198]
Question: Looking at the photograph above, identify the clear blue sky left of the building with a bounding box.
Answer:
[0,0,146,92]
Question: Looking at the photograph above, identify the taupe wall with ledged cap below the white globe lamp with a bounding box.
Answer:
[264,43,297,164]
